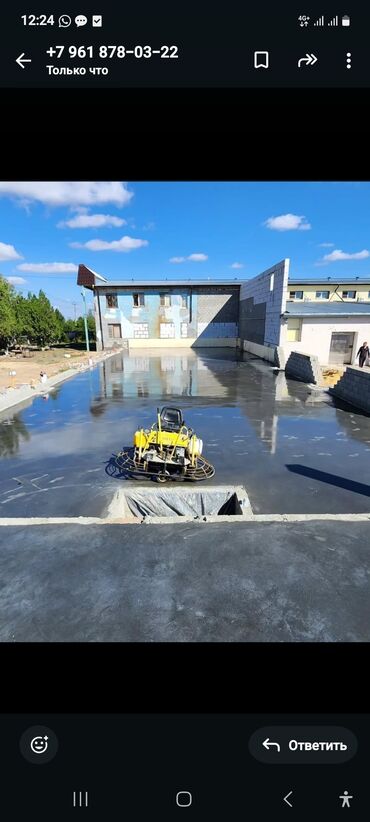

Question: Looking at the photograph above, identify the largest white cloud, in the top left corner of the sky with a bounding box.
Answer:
[0,181,134,206]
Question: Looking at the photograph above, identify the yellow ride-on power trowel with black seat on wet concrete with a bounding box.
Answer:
[116,406,215,482]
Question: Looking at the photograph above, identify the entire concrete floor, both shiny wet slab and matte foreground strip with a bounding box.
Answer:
[0,349,370,642]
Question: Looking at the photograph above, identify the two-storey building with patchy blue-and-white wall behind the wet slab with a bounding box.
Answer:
[78,266,240,349]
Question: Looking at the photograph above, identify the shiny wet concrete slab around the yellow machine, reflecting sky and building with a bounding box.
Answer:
[0,349,370,516]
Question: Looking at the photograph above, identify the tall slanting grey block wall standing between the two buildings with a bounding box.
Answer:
[239,259,289,346]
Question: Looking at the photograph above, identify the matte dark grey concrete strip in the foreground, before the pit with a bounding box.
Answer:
[0,521,370,642]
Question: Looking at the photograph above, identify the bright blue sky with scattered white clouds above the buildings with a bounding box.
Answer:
[0,182,370,317]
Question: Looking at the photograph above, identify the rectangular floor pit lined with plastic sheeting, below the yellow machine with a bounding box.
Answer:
[108,486,251,520]
